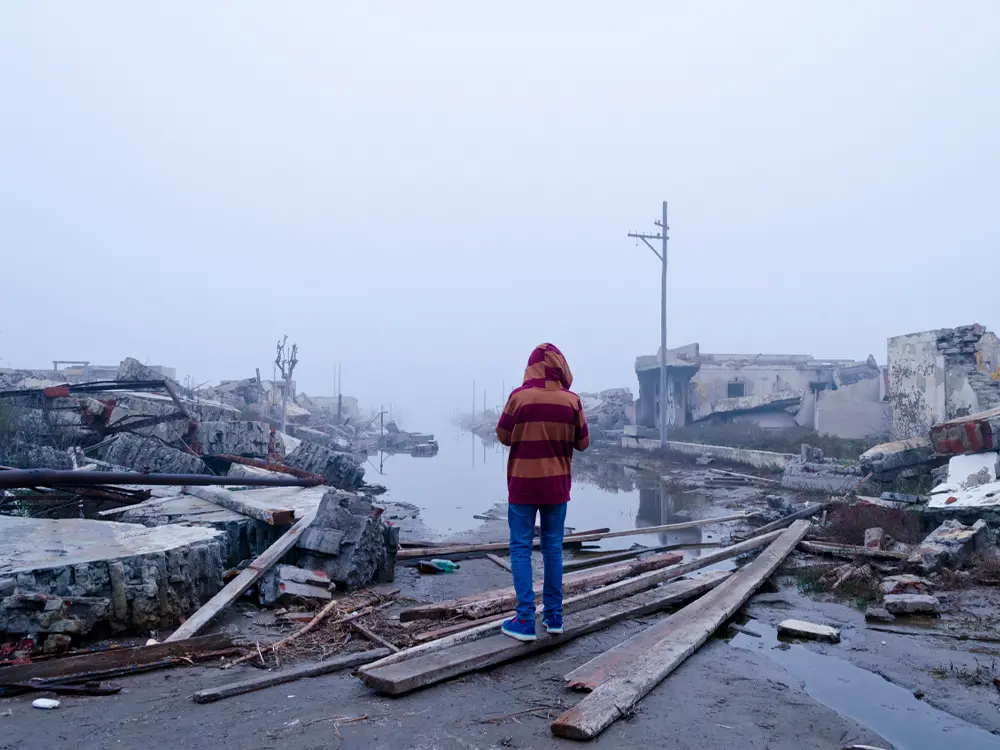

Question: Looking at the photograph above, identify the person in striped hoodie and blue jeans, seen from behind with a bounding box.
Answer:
[497,344,590,641]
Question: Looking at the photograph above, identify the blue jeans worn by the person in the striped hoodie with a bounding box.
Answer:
[507,503,566,620]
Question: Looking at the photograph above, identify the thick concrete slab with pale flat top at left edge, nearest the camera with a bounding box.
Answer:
[0,516,223,636]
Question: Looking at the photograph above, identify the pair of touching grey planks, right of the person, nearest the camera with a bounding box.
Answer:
[551,520,809,740]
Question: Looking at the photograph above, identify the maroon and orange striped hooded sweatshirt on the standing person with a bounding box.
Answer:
[497,344,590,505]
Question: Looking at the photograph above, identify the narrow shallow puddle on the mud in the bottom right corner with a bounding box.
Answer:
[729,620,1000,750]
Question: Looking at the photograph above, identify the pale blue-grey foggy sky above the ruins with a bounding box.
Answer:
[0,0,1000,428]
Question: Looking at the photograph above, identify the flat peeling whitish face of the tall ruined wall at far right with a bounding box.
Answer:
[887,331,947,440]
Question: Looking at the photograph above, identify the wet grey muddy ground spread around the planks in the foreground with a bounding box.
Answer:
[0,456,1000,750]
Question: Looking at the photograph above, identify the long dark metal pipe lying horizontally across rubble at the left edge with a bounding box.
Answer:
[0,469,323,489]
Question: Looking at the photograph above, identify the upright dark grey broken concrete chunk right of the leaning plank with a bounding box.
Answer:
[298,490,398,589]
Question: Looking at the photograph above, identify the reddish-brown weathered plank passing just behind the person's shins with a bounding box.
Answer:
[399,553,682,622]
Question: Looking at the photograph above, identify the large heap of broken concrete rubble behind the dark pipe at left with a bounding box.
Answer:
[0,358,372,489]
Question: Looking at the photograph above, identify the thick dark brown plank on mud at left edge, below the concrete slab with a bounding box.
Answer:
[0,634,233,682]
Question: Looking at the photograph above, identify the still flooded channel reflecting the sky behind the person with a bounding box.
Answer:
[365,426,726,549]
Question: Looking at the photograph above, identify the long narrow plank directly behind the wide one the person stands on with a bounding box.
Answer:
[372,531,781,669]
